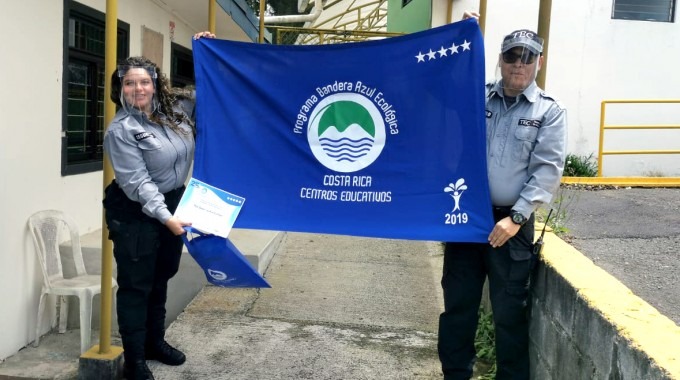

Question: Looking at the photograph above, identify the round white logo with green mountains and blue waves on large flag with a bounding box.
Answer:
[307,92,385,173]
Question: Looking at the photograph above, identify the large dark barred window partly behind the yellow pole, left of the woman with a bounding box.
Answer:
[61,0,130,175]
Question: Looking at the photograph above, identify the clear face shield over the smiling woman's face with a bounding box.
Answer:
[118,65,158,114]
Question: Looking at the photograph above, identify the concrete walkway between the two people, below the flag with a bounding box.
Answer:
[150,233,442,380]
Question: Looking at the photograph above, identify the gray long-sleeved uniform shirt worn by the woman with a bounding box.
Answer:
[104,109,194,224]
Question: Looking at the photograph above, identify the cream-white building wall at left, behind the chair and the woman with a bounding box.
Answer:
[0,0,247,361]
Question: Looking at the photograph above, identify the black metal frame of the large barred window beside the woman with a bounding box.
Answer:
[61,0,130,176]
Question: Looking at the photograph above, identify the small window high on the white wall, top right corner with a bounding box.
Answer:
[612,0,676,22]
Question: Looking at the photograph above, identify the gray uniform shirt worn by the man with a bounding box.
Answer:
[486,82,567,218]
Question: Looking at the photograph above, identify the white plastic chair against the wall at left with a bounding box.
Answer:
[28,210,118,353]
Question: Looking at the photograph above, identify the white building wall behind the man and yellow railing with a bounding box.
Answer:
[433,0,680,176]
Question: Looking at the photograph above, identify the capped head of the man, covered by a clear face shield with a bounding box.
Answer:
[496,30,543,96]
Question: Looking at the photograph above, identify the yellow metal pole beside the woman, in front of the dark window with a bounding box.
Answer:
[99,0,118,355]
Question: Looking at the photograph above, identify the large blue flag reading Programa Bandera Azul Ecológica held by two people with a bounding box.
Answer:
[193,20,493,242]
